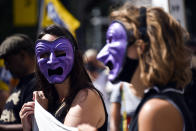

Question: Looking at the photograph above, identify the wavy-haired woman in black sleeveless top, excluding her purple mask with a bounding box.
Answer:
[100,3,194,131]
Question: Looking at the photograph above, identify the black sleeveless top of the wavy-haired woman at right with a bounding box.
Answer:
[129,87,195,131]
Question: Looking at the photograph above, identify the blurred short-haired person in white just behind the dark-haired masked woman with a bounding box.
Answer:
[83,48,114,122]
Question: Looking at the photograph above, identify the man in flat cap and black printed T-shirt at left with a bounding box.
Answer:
[0,34,36,130]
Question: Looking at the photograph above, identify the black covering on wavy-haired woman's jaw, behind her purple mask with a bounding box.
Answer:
[111,57,139,83]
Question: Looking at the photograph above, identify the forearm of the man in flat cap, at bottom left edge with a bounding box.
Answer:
[0,124,22,131]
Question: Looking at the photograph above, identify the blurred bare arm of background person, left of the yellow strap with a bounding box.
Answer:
[110,103,121,131]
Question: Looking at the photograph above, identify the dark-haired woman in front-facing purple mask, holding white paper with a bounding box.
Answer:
[20,25,107,131]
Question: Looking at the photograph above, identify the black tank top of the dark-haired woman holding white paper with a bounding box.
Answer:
[53,90,108,131]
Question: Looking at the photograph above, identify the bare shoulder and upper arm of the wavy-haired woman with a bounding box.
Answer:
[138,98,183,131]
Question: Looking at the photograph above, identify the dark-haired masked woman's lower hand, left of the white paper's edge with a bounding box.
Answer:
[19,102,35,131]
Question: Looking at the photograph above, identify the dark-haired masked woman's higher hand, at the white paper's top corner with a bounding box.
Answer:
[33,91,48,110]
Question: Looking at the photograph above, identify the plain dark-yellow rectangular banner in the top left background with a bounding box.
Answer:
[13,0,37,26]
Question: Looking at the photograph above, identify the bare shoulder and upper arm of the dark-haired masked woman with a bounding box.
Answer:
[64,89,105,128]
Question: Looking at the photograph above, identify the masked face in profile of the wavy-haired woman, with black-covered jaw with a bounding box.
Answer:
[97,20,138,83]
